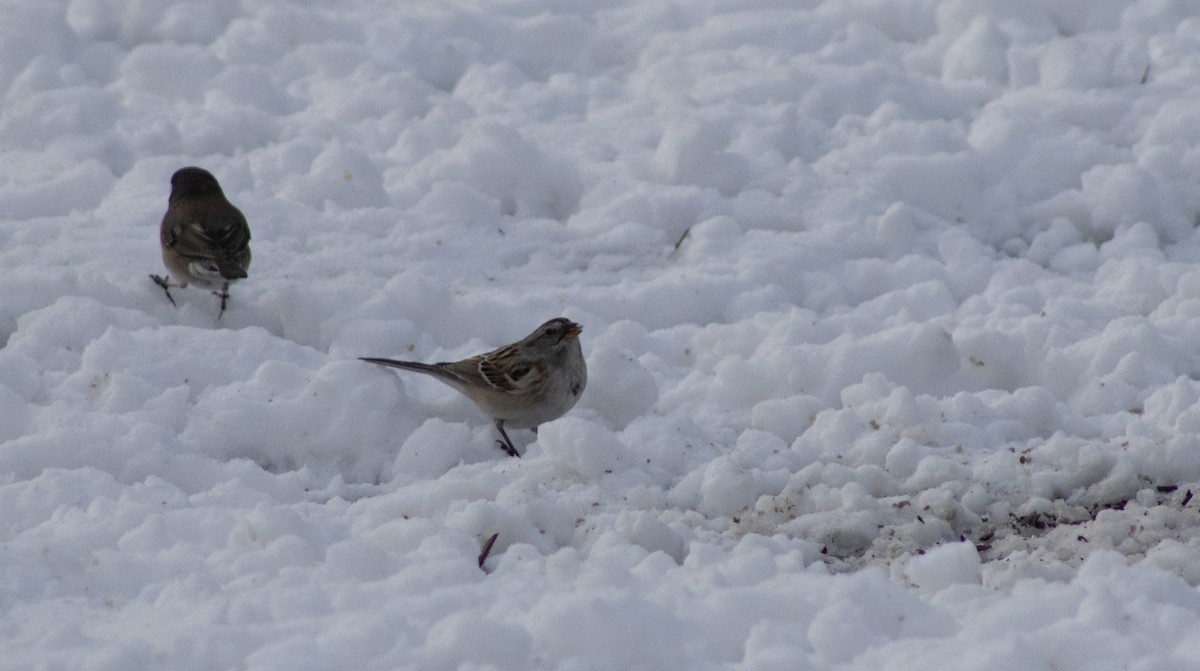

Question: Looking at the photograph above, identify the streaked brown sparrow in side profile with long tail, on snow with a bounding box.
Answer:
[361,317,588,456]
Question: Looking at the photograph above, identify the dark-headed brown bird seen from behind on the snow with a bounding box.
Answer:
[150,167,250,318]
